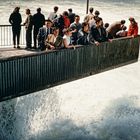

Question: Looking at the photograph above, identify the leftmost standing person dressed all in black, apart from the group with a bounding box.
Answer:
[9,7,22,48]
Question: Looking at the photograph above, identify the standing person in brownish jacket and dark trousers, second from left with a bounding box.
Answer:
[24,9,33,49]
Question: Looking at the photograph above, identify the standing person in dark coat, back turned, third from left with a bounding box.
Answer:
[33,8,45,49]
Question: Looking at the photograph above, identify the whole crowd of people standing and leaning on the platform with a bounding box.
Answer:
[9,6,138,51]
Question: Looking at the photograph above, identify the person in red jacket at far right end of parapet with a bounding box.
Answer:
[127,17,138,37]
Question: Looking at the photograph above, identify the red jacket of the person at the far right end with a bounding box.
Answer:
[127,23,138,36]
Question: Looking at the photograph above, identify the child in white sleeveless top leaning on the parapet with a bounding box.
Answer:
[63,28,75,49]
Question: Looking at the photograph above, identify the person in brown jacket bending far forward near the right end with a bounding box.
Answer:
[107,20,125,39]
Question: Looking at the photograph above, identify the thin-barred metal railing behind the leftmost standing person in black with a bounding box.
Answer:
[0,25,25,47]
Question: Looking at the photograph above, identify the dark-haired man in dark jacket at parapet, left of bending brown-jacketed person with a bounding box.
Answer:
[89,18,109,46]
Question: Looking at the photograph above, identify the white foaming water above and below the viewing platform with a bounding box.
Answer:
[0,0,140,140]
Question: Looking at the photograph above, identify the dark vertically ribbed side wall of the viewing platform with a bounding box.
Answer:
[0,37,140,101]
